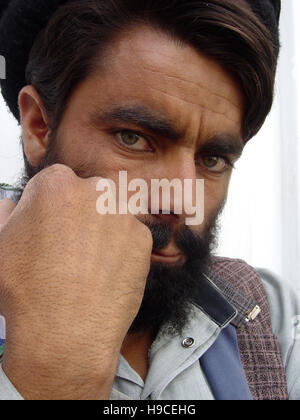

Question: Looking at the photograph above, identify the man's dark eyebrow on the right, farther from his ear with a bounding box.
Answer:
[198,133,245,158]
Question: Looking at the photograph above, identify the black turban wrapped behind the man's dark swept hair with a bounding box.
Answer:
[0,0,281,120]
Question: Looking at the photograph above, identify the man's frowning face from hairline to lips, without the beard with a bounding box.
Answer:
[32,27,243,334]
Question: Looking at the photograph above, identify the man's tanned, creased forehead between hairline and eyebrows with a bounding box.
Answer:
[67,27,243,141]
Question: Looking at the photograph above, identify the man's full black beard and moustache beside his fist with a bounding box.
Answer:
[128,217,220,336]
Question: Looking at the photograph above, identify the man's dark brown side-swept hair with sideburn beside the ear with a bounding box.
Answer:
[26,0,278,177]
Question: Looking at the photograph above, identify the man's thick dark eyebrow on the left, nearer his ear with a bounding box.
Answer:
[92,106,183,141]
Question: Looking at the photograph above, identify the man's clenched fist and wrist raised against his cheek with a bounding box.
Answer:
[0,165,152,399]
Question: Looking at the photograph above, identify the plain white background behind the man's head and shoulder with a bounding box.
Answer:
[0,0,300,285]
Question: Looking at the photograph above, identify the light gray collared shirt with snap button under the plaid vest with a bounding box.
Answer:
[0,270,300,400]
